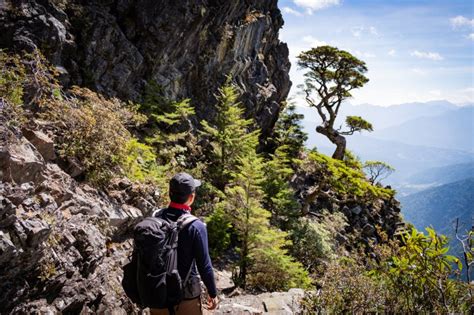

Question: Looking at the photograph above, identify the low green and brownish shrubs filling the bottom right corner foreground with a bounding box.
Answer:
[303,229,472,314]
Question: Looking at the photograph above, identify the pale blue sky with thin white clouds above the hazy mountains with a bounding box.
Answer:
[278,0,474,106]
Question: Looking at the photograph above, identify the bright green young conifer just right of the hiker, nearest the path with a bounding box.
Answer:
[220,152,309,290]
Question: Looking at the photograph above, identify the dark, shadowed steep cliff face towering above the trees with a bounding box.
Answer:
[0,0,291,141]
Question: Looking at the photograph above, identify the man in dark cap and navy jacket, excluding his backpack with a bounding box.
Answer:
[150,173,218,315]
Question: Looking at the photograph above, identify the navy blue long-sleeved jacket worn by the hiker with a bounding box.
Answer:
[162,207,217,298]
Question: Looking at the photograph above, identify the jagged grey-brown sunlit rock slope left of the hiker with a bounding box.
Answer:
[0,116,157,314]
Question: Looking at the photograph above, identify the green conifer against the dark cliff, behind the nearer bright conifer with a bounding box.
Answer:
[201,83,259,189]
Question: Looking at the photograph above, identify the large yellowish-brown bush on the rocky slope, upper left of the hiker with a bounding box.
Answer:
[42,87,148,185]
